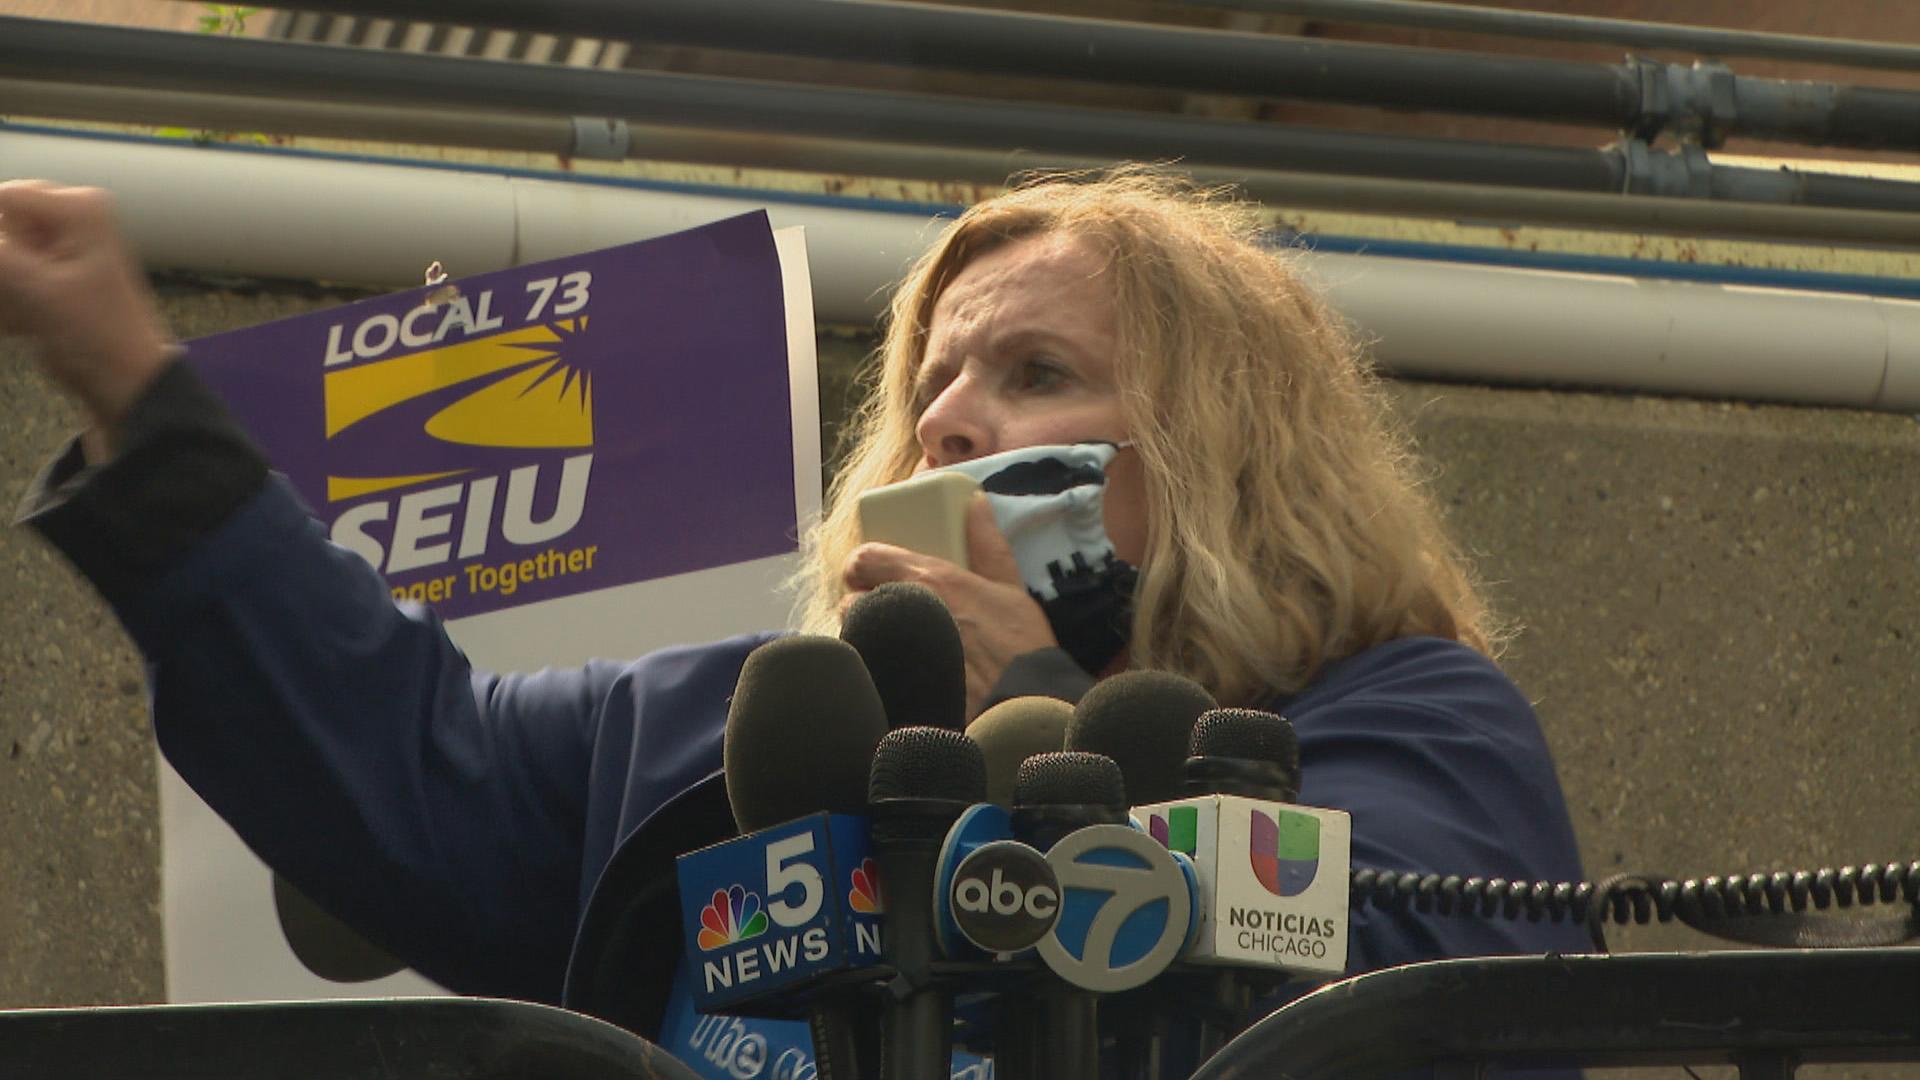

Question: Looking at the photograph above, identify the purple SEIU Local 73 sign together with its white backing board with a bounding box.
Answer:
[161,213,820,1001]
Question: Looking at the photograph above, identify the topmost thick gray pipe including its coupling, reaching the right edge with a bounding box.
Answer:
[206,0,1920,150]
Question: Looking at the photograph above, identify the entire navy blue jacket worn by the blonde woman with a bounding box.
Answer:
[29,367,1586,1003]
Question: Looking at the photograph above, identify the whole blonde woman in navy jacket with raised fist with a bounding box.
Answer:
[0,171,1584,1049]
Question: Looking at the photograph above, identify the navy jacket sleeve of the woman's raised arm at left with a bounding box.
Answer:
[23,363,610,1001]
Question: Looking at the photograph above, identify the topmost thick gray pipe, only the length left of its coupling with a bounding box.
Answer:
[191,0,1636,129]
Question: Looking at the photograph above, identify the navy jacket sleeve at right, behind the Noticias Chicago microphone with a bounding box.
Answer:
[1288,642,1590,974]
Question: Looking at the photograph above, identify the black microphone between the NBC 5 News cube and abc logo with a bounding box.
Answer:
[868,726,987,1080]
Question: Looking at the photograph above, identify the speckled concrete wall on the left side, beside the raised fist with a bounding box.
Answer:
[0,288,364,1007]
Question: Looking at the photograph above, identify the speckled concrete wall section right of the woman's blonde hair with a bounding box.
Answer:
[1400,384,1920,947]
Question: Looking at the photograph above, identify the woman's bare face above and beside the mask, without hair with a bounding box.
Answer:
[914,233,1146,565]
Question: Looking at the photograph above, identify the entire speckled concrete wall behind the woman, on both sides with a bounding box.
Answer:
[0,288,1920,1053]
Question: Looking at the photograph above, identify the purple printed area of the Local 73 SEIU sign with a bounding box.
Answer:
[188,213,797,617]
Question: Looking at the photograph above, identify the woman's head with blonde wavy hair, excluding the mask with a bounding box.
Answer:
[806,171,1494,705]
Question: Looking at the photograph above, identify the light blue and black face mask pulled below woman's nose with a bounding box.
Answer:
[941,442,1140,675]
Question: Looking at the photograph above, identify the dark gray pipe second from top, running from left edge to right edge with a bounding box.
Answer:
[11,17,1920,209]
